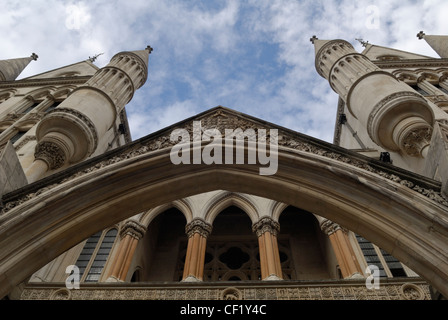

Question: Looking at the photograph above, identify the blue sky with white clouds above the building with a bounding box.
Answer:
[0,0,448,142]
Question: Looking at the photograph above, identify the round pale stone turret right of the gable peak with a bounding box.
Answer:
[311,37,434,157]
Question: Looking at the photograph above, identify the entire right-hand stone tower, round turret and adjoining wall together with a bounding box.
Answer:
[312,32,448,200]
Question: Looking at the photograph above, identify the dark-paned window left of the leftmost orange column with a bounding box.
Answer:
[76,229,117,282]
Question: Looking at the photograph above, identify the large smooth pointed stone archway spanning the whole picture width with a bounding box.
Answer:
[0,142,448,296]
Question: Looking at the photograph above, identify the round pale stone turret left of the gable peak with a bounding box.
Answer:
[27,46,152,182]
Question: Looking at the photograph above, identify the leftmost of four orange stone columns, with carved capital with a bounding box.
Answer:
[107,220,146,282]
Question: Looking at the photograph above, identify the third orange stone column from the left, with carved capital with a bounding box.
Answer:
[252,217,283,280]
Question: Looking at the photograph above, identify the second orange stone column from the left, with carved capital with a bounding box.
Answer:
[182,218,212,282]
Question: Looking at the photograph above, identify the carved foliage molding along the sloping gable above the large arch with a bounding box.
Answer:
[2,109,448,213]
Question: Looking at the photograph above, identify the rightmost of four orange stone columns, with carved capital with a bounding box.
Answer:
[319,218,363,279]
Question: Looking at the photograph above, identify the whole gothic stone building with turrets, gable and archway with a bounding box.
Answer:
[0,32,448,300]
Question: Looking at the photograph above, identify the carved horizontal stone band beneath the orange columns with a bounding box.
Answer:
[21,279,431,300]
